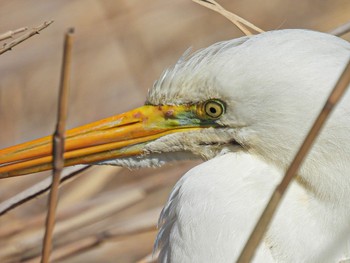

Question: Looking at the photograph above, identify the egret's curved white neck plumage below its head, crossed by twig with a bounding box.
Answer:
[155,153,349,263]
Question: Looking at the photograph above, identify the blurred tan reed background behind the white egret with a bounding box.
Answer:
[0,0,350,262]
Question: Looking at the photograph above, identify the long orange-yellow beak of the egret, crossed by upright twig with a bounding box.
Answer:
[0,105,216,178]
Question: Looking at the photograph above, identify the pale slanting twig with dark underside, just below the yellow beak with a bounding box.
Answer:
[0,166,91,216]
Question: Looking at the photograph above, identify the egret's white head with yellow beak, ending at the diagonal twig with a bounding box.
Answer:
[0,30,349,177]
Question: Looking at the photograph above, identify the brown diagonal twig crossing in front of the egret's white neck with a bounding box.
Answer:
[237,60,350,263]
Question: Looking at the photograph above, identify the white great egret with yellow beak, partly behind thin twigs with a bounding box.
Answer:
[0,30,350,262]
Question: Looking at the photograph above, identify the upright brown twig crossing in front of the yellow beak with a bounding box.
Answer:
[41,28,74,263]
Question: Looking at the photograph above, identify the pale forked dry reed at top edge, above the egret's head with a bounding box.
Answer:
[192,0,264,36]
